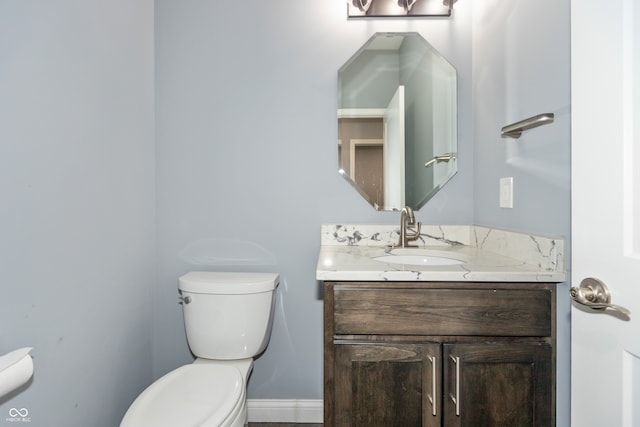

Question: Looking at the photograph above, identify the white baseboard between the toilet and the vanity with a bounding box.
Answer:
[247,399,324,424]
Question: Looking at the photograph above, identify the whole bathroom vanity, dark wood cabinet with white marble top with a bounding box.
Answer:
[316,225,565,427]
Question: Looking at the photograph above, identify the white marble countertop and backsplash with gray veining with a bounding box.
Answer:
[316,224,565,283]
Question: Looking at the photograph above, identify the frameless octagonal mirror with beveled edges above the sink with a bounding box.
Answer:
[338,33,458,210]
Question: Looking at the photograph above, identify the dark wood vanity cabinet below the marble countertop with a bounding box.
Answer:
[324,282,555,427]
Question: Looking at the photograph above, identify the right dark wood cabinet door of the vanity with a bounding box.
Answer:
[443,343,555,427]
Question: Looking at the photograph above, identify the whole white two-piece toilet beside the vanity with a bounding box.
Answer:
[120,271,279,427]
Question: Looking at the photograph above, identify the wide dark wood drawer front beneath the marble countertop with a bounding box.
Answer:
[333,286,553,337]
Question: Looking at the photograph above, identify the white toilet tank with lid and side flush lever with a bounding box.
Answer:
[178,271,279,360]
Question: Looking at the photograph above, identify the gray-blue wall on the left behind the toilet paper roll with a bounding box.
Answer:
[0,0,155,427]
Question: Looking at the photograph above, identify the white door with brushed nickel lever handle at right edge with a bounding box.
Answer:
[571,0,640,427]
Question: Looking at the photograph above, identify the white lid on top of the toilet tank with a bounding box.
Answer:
[178,271,280,295]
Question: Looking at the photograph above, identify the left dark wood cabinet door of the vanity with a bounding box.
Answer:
[334,341,442,427]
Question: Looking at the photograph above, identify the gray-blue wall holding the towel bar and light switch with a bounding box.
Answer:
[473,0,571,426]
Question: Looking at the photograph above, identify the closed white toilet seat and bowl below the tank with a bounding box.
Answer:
[120,364,245,427]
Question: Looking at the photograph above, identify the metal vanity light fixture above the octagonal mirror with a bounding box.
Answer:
[347,0,457,18]
